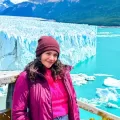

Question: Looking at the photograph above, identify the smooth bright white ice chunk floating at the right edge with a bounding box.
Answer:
[104,77,120,89]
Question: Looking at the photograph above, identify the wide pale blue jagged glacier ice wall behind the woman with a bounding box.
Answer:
[0,16,97,70]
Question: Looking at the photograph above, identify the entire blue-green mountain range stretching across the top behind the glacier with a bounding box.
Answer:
[0,0,120,26]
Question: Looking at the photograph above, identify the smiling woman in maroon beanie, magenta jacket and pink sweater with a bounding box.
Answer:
[12,36,79,120]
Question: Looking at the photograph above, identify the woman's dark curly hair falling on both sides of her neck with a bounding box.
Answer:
[25,58,68,81]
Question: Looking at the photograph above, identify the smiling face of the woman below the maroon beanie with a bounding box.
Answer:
[41,50,58,68]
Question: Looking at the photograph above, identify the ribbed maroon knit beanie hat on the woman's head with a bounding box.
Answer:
[36,36,60,57]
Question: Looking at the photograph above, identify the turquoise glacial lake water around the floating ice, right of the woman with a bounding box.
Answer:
[71,27,120,120]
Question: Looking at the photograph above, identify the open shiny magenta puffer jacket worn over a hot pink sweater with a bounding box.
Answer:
[12,71,80,120]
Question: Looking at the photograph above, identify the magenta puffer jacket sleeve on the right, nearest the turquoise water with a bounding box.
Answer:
[67,72,80,120]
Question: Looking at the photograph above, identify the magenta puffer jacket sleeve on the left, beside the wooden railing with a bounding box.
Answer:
[12,72,29,120]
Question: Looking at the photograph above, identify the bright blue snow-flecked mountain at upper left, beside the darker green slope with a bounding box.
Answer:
[1,0,77,19]
